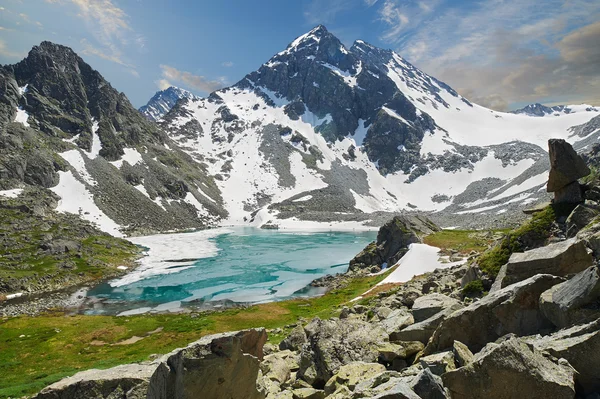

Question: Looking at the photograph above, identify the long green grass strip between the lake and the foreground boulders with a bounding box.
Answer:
[0,275,385,398]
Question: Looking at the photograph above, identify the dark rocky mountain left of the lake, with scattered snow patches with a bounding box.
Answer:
[0,42,227,235]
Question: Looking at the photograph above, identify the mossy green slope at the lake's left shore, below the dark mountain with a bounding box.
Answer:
[0,208,140,293]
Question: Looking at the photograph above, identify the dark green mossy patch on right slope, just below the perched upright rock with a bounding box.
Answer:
[477,206,559,277]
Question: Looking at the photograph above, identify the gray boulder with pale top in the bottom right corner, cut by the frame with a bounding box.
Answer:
[528,319,600,395]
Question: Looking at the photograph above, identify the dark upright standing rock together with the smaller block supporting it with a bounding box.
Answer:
[547,139,590,204]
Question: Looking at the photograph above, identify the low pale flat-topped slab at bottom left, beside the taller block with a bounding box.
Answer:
[35,364,157,399]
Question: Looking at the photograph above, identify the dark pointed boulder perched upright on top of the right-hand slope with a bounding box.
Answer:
[547,139,591,193]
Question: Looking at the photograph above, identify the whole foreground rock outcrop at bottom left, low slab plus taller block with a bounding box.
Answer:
[36,329,267,399]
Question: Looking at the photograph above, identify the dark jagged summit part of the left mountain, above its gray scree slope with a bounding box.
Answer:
[3,42,164,160]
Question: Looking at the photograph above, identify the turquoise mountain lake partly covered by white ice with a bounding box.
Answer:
[86,228,376,314]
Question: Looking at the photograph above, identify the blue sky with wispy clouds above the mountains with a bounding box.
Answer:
[0,0,600,110]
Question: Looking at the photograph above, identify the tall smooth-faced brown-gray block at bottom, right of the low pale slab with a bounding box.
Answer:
[147,328,267,399]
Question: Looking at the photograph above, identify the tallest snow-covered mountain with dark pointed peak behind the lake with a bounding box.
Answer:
[160,26,599,227]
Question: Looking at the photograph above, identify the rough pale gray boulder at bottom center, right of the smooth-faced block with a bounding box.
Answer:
[297,317,388,388]
